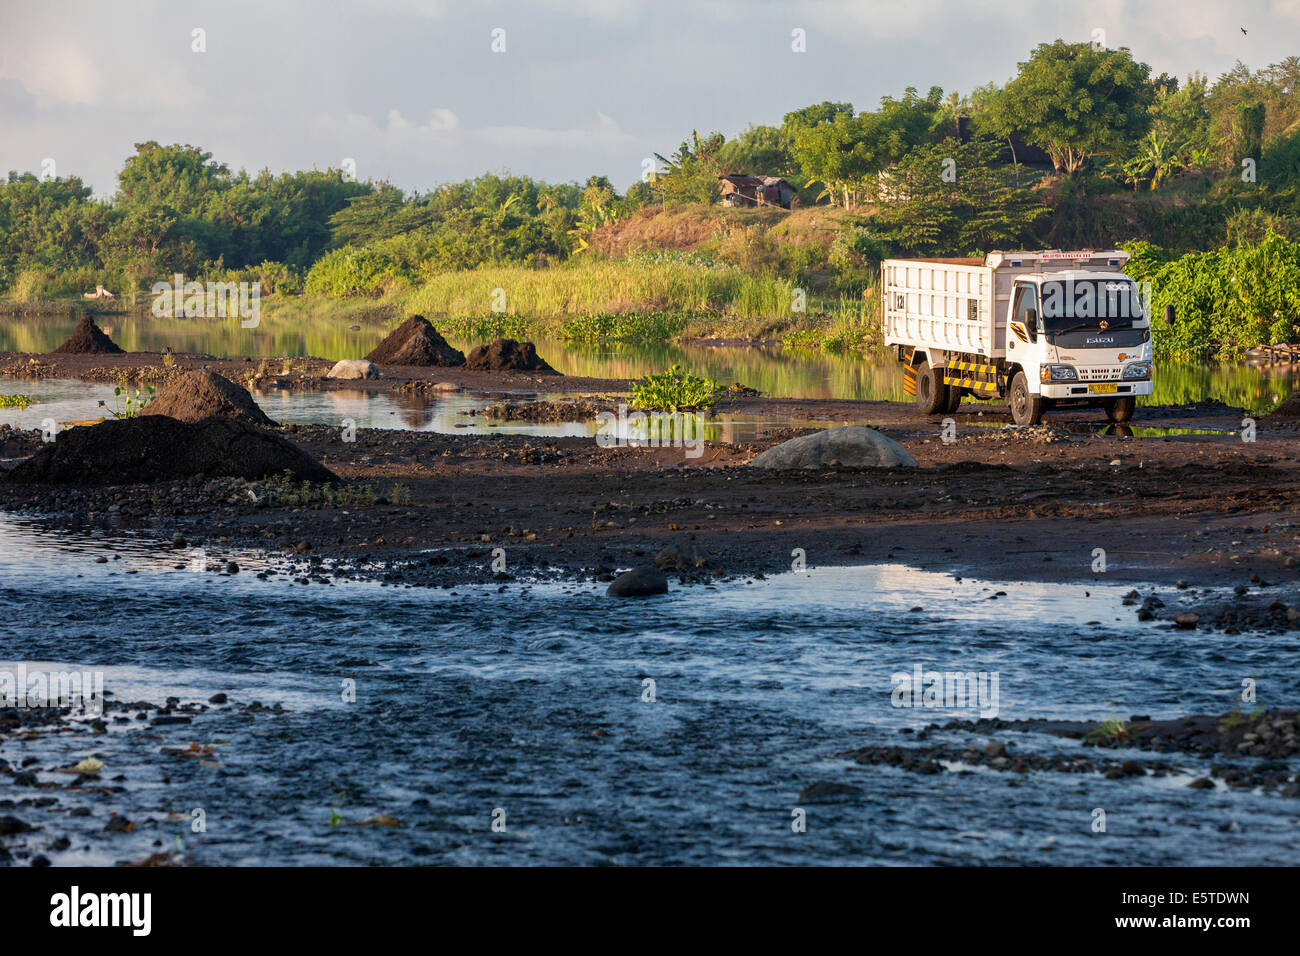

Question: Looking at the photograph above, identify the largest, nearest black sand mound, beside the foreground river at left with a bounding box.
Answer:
[9,415,334,485]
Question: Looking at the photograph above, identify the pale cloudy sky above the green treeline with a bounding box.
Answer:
[0,0,1300,196]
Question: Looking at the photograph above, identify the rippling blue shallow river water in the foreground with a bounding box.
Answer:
[0,516,1300,865]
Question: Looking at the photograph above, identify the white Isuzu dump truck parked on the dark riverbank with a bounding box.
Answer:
[880,250,1152,425]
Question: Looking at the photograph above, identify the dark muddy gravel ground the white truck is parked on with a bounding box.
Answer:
[0,343,1300,627]
